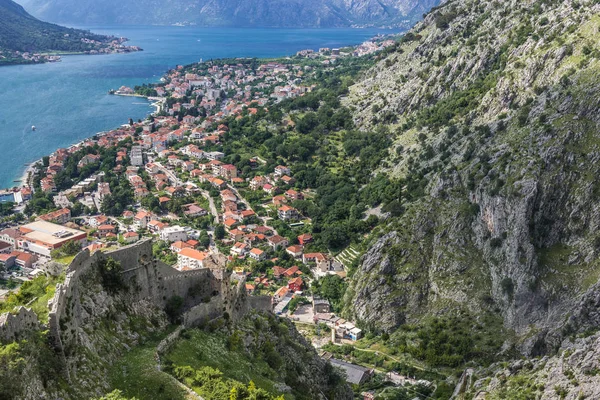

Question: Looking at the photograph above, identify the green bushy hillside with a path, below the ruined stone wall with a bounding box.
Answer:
[104,313,343,400]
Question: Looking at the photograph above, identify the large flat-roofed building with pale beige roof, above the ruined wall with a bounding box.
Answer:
[17,221,87,257]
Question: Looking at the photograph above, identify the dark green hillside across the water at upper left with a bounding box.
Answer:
[0,0,115,52]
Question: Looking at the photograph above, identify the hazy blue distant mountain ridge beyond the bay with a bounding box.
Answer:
[19,0,440,28]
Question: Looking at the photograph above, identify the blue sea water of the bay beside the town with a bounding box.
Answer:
[0,26,398,188]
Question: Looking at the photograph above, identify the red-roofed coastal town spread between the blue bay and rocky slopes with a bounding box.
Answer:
[0,36,426,398]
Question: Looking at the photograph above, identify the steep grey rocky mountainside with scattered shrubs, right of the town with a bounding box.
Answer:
[345,0,600,355]
